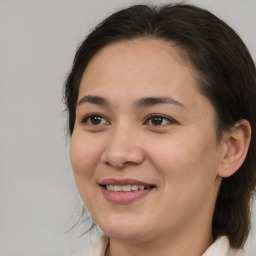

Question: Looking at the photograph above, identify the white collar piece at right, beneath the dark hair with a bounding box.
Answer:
[202,236,246,256]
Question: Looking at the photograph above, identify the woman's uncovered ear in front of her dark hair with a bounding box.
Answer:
[218,119,251,178]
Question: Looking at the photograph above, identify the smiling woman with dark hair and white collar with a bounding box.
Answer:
[65,4,256,256]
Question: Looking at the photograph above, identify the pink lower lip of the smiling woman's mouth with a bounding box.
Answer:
[101,186,153,204]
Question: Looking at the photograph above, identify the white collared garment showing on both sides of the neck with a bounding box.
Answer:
[73,236,246,256]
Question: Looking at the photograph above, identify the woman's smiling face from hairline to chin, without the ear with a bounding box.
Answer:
[71,39,224,242]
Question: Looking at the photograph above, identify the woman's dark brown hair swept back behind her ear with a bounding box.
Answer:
[64,4,256,248]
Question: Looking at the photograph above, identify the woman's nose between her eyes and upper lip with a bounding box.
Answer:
[102,127,145,169]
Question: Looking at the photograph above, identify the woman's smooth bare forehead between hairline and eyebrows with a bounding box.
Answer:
[79,38,202,100]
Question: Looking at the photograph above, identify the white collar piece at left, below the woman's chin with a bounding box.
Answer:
[73,236,109,256]
